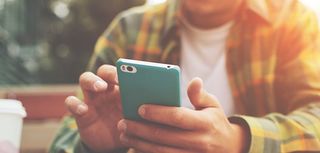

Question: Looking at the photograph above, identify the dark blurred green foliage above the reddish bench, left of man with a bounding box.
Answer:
[0,0,145,85]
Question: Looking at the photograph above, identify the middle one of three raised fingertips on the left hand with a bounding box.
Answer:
[79,72,108,92]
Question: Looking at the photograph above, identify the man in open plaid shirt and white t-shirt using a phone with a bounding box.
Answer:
[51,0,320,153]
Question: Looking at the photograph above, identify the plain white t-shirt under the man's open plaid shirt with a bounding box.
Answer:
[180,20,234,116]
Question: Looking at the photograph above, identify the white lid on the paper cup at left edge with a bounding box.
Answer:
[0,99,27,117]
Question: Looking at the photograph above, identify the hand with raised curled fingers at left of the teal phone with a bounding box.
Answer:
[65,65,123,152]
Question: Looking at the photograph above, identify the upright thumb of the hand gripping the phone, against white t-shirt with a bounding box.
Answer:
[188,78,220,110]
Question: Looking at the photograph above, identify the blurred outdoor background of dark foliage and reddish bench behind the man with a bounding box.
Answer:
[0,0,320,153]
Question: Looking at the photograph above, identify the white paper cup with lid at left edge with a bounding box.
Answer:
[0,99,26,153]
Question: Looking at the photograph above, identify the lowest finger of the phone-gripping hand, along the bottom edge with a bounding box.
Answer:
[120,134,192,153]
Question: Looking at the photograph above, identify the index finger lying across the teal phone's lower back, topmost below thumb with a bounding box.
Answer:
[139,105,208,130]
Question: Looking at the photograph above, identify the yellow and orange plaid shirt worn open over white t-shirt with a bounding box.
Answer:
[50,0,320,153]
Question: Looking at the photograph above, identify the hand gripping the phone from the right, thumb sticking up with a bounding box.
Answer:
[118,79,248,153]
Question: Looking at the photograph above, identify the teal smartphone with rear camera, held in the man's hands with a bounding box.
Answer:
[116,58,180,121]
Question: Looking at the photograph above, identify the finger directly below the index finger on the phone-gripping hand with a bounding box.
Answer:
[118,120,208,150]
